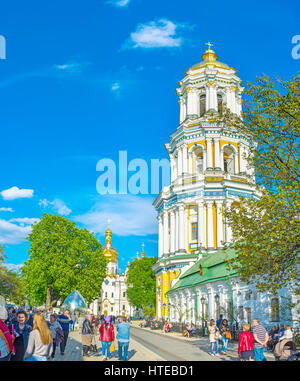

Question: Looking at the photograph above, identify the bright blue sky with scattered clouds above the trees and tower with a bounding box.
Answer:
[0,0,300,271]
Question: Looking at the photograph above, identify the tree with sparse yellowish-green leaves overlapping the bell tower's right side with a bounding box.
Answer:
[220,75,300,293]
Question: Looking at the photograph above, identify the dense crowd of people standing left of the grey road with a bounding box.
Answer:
[0,306,130,361]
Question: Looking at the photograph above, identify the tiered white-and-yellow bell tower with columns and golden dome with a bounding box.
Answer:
[154,44,259,317]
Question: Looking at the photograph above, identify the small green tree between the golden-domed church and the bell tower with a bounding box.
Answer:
[126,257,157,308]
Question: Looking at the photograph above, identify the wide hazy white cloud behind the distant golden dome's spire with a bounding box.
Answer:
[73,195,157,236]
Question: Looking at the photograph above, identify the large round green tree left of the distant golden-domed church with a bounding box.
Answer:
[22,214,107,307]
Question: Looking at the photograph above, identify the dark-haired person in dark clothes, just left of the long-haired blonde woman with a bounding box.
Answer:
[9,310,32,361]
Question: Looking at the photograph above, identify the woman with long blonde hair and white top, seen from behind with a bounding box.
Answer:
[24,313,53,361]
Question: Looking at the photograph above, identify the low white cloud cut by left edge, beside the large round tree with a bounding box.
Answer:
[0,219,37,245]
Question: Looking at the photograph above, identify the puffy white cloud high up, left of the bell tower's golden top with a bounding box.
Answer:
[124,19,184,48]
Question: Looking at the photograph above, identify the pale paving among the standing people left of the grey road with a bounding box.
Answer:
[50,331,164,361]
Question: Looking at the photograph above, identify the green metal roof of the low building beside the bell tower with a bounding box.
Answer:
[167,247,237,293]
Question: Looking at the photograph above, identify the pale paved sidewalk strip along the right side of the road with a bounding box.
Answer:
[131,321,275,361]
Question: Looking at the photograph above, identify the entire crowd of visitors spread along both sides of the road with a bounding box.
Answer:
[0,306,293,361]
